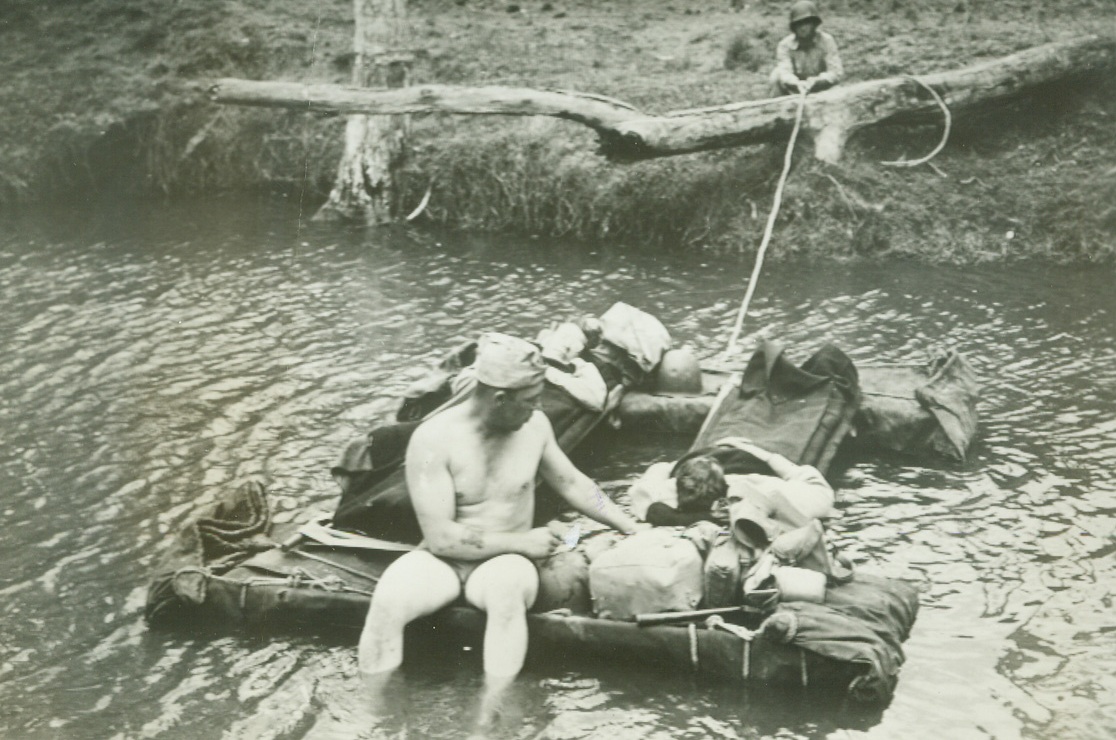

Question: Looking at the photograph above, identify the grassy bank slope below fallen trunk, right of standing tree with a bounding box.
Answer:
[390,76,1116,262]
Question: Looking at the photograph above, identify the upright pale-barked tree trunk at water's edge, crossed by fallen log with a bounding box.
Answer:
[317,0,410,223]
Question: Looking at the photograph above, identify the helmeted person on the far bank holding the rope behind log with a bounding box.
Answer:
[771,0,845,96]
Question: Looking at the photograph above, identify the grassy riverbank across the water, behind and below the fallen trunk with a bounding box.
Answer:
[0,0,1116,261]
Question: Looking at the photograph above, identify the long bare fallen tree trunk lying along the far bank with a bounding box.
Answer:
[210,36,1116,162]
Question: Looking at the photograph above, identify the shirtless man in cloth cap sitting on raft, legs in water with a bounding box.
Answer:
[359,334,638,677]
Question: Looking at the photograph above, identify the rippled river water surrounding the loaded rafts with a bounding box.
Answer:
[0,198,1116,739]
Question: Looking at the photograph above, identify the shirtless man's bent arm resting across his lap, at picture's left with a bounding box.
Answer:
[406,424,554,560]
